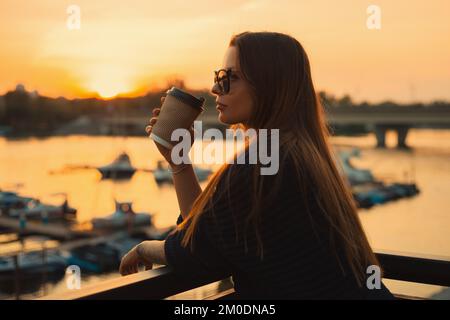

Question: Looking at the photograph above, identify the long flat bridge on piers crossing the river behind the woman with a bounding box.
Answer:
[98,106,450,148]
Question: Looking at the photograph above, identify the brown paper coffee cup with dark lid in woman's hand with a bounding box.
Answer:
[150,87,205,149]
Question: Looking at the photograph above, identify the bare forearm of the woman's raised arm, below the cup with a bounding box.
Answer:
[172,164,202,218]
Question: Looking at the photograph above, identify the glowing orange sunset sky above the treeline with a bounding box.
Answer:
[0,0,450,102]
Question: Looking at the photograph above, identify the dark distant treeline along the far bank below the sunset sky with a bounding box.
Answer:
[0,82,450,135]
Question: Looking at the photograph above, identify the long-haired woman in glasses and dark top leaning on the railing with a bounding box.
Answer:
[120,32,392,299]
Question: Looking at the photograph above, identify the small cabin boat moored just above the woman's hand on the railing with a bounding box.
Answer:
[91,201,152,229]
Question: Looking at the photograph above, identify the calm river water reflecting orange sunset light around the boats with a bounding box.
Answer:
[0,130,450,296]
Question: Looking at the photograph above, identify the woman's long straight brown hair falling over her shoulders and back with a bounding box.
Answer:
[178,32,379,285]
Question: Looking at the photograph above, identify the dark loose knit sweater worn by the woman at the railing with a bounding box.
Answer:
[165,151,392,299]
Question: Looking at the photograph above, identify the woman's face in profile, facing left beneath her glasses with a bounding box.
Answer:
[211,46,253,125]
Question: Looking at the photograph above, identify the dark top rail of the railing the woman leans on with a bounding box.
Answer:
[43,251,450,300]
